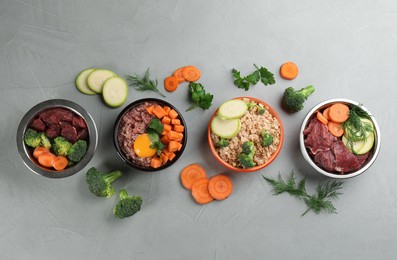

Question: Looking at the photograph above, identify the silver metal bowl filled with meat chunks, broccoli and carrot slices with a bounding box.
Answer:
[16,99,98,178]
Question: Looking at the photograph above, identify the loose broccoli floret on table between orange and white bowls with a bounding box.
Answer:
[283,86,314,113]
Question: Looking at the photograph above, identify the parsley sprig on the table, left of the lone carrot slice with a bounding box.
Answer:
[232,64,276,91]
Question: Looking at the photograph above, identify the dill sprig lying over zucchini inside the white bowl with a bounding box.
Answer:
[343,105,374,142]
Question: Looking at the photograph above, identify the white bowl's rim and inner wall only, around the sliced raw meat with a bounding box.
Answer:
[299,98,381,179]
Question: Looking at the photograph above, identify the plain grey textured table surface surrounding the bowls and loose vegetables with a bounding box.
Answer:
[0,0,397,259]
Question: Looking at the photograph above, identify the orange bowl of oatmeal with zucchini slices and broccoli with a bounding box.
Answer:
[207,97,284,172]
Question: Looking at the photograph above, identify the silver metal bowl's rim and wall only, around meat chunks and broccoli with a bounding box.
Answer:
[17,99,98,178]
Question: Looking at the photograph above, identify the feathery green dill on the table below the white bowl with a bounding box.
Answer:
[263,171,343,216]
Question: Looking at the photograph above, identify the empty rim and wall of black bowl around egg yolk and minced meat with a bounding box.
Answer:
[113,98,187,172]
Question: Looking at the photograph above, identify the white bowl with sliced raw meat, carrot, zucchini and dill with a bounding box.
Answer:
[299,98,381,179]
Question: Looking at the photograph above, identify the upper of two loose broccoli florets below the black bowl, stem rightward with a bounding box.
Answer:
[86,167,122,198]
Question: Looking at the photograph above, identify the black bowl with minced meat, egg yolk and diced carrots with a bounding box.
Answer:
[113,98,187,171]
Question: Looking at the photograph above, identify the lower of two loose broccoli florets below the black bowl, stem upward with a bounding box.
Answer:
[113,189,142,219]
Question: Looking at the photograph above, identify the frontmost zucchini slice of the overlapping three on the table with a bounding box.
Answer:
[102,76,128,108]
